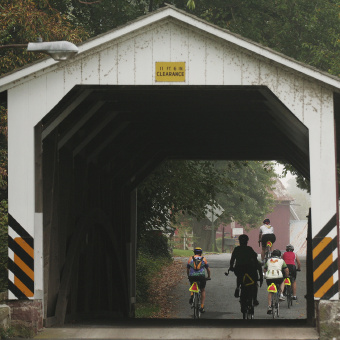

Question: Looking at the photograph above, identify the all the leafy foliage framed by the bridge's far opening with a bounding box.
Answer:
[138,161,276,240]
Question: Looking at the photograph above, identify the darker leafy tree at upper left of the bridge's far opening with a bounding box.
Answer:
[138,161,222,233]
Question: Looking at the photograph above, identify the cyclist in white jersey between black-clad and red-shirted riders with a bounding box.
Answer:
[263,249,289,314]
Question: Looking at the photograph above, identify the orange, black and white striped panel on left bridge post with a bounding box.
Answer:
[8,214,34,299]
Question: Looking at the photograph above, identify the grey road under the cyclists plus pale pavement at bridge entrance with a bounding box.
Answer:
[36,254,319,340]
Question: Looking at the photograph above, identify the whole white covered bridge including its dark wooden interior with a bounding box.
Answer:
[0,6,340,334]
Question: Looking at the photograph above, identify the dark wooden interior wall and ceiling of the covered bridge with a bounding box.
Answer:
[35,85,309,325]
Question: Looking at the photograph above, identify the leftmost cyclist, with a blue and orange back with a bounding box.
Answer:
[187,247,210,313]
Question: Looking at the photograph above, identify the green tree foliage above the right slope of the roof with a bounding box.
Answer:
[182,0,340,76]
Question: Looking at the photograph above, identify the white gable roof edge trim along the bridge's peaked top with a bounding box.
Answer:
[0,5,340,92]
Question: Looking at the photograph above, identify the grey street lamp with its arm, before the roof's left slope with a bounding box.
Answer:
[0,38,78,61]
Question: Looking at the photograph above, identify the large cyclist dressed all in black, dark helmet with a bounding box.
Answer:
[229,234,263,306]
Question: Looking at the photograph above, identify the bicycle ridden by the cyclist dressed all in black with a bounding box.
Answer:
[224,268,256,320]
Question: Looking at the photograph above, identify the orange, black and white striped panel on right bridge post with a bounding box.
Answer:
[313,215,339,300]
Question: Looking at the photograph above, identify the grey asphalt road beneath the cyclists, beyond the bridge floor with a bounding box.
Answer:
[172,254,307,320]
